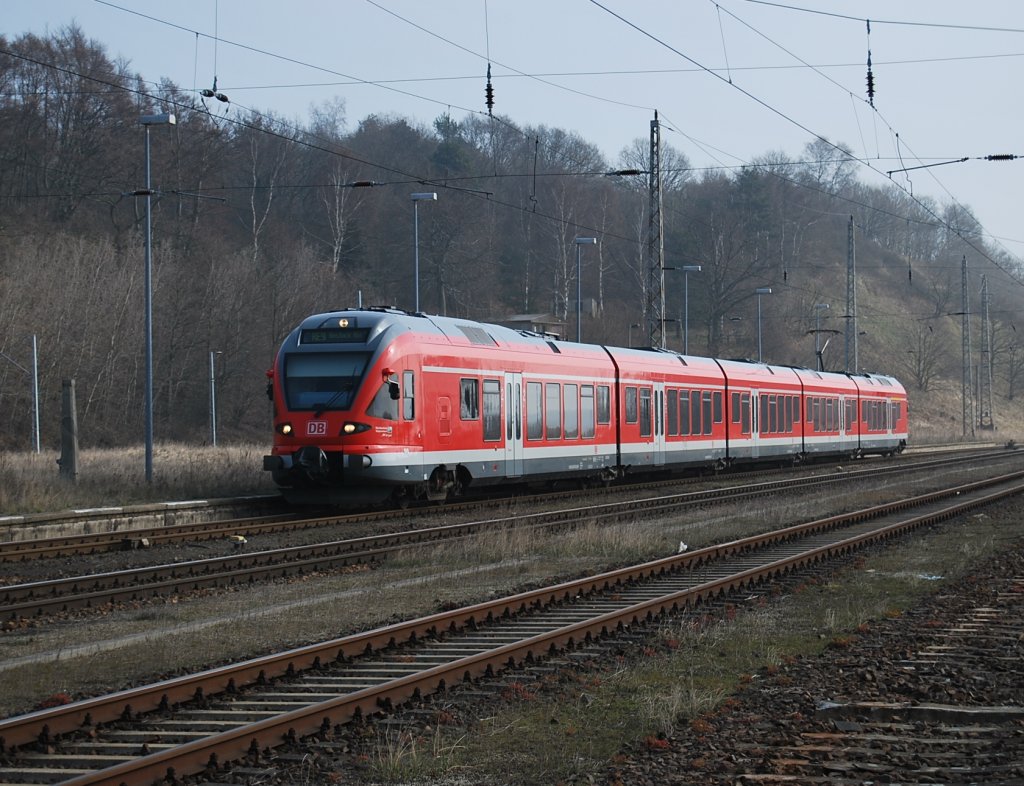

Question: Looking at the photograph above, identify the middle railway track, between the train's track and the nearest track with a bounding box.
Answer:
[0,451,1019,624]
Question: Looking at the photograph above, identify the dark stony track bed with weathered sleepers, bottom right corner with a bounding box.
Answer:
[609,551,1024,786]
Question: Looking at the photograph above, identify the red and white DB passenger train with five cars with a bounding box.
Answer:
[263,308,908,506]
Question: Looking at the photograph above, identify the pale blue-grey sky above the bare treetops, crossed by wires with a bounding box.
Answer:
[8,0,1024,257]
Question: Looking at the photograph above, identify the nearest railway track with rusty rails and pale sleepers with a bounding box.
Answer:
[0,462,1024,785]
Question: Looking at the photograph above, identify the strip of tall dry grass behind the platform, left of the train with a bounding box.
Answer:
[0,444,273,514]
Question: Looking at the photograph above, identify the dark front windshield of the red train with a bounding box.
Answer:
[285,352,370,411]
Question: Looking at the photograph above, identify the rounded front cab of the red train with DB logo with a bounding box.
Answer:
[263,311,423,506]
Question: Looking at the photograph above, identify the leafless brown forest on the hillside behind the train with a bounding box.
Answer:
[0,28,1024,448]
